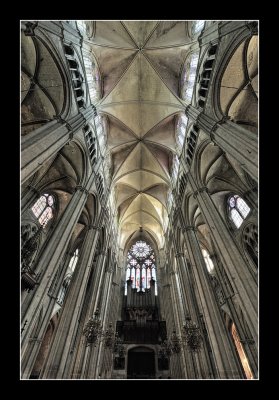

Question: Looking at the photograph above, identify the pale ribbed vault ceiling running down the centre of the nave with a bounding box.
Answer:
[87,21,195,248]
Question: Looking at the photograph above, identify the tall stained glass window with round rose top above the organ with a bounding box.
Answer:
[125,240,157,295]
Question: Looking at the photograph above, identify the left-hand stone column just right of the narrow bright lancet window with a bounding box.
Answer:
[42,226,99,379]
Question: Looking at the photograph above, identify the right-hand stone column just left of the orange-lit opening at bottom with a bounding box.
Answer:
[185,226,241,379]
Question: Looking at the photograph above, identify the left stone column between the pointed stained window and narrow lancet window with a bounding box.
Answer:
[21,182,91,378]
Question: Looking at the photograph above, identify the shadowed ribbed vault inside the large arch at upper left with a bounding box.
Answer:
[21,32,66,136]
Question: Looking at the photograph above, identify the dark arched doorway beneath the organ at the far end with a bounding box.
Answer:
[127,346,155,379]
